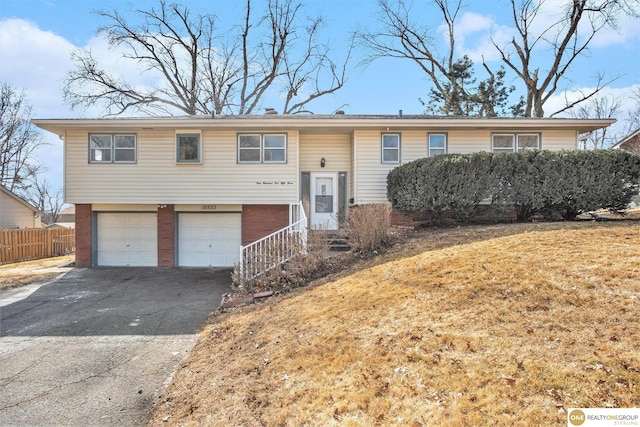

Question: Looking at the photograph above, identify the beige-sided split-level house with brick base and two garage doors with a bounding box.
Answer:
[34,114,614,267]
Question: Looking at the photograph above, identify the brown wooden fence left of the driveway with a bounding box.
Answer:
[0,228,76,264]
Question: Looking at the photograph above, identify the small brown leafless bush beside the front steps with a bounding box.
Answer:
[344,203,391,253]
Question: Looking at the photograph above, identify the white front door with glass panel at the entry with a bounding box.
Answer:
[310,172,338,230]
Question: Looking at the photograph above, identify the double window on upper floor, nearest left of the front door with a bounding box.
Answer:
[238,133,287,163]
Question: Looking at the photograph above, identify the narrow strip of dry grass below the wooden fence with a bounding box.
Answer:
[0,255,75,290]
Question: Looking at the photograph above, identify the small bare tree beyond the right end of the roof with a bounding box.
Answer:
[571,96,622,150]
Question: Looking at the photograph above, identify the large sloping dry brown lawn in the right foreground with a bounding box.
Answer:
[150,222,640,426]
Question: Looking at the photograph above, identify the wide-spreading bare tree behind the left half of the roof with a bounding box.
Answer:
[64,0,353,115]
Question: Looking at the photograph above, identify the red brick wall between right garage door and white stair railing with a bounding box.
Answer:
[242,205,289,245]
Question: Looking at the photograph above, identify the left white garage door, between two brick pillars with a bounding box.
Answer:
[98,212,158,267]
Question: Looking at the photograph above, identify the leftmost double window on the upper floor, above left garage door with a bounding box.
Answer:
[89,133,137,163]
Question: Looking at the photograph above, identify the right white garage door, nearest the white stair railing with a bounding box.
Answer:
[178,213,242,267]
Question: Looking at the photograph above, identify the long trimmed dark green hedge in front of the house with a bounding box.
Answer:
[387,150,640,222]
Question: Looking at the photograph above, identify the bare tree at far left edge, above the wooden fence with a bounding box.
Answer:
[0,83,44,193]
